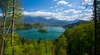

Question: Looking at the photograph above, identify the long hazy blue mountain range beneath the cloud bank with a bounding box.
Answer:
[23,16,80,25]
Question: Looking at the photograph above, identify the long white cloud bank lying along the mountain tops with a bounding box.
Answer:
[23,11,92,21]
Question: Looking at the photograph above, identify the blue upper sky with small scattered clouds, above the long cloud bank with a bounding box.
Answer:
[24,0,82,12]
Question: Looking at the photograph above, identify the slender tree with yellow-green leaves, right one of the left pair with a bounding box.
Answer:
[11,0,22,55]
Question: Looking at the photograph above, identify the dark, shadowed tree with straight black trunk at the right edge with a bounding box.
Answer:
[82,0,100,55]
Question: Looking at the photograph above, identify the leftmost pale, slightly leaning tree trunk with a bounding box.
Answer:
[1,1,10,55]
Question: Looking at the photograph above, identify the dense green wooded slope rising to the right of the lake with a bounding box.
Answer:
[54,21,94,55]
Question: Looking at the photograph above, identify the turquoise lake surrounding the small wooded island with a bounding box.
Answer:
[15,27,65,40]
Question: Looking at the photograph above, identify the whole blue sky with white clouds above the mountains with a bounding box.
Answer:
[0,0,93,21]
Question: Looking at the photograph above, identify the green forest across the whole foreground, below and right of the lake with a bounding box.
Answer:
[0,21,97,55]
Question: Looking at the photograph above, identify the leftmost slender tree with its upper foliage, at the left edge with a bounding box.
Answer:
[0,0,10,55]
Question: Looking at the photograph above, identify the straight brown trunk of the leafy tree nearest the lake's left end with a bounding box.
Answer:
[11,0,15,55]
